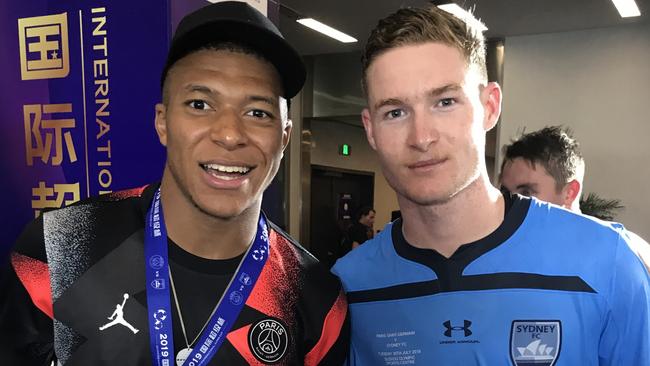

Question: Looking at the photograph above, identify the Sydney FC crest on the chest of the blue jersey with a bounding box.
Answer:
[510,320,562,366]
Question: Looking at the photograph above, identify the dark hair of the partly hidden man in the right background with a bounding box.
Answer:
[501,126,585,191]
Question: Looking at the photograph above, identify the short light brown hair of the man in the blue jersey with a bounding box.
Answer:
[361,6,487,94]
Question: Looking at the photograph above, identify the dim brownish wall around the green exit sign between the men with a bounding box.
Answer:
[311,120,399,229]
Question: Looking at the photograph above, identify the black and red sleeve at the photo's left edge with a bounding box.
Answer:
[0,218,54,366]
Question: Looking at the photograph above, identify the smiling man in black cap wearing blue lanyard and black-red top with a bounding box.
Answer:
[0,2,349,366]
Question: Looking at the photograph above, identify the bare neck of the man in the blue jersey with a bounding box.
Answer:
[398,174,505,258]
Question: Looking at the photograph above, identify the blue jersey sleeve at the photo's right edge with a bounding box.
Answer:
[599,233,650,365]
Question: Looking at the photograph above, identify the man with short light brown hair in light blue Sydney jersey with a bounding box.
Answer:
[333,8,650,366]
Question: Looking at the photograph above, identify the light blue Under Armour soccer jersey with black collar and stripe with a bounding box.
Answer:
[333,196,650,366]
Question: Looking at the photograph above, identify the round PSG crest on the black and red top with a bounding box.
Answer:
[248,318,289,363]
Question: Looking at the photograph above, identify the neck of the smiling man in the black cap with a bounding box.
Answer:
[160,171,261,259]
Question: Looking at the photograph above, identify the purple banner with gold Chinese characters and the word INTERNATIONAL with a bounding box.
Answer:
[0,0,168,254]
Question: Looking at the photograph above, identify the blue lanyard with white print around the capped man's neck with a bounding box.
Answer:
[144,189,269,366]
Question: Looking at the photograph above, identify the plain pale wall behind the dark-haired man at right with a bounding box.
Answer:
[497,24,650,240]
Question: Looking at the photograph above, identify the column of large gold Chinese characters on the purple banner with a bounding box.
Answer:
[18,13,80,216]
